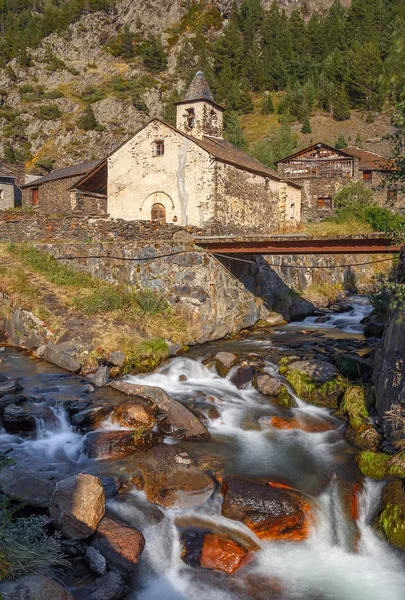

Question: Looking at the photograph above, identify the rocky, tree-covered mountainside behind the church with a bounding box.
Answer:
[0,0,405,173]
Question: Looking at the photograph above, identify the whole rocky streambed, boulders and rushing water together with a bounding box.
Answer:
[0,298,405,600]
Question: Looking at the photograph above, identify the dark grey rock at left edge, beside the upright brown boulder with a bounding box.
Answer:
[0,465,56,508]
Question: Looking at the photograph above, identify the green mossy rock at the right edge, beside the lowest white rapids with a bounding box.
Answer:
[378,481,405,550]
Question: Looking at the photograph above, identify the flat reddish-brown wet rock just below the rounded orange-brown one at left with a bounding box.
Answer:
[83,430,160,460]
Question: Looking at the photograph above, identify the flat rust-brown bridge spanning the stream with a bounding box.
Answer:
[194,233,401,254]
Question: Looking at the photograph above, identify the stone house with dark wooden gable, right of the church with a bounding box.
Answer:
[277,143,405,221]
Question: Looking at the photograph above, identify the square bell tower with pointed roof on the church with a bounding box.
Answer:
[176,71,224,139]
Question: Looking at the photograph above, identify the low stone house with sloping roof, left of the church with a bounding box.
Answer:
[21,160,105,214]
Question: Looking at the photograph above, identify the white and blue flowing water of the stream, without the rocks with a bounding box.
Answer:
[0,297,405,600]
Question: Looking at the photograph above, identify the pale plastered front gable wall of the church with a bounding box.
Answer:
[108,121,215,227]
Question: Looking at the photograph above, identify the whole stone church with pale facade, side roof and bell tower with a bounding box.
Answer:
[71,72,301,233]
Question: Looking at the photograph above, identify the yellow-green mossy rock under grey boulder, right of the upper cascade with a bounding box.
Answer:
[286,367,348,408]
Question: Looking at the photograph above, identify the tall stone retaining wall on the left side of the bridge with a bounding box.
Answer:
[40,242,267,343]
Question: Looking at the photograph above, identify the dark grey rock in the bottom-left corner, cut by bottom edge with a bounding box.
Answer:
[0,575,74,600]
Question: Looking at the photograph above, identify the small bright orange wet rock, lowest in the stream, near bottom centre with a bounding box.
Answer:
[200,533,251,574]
